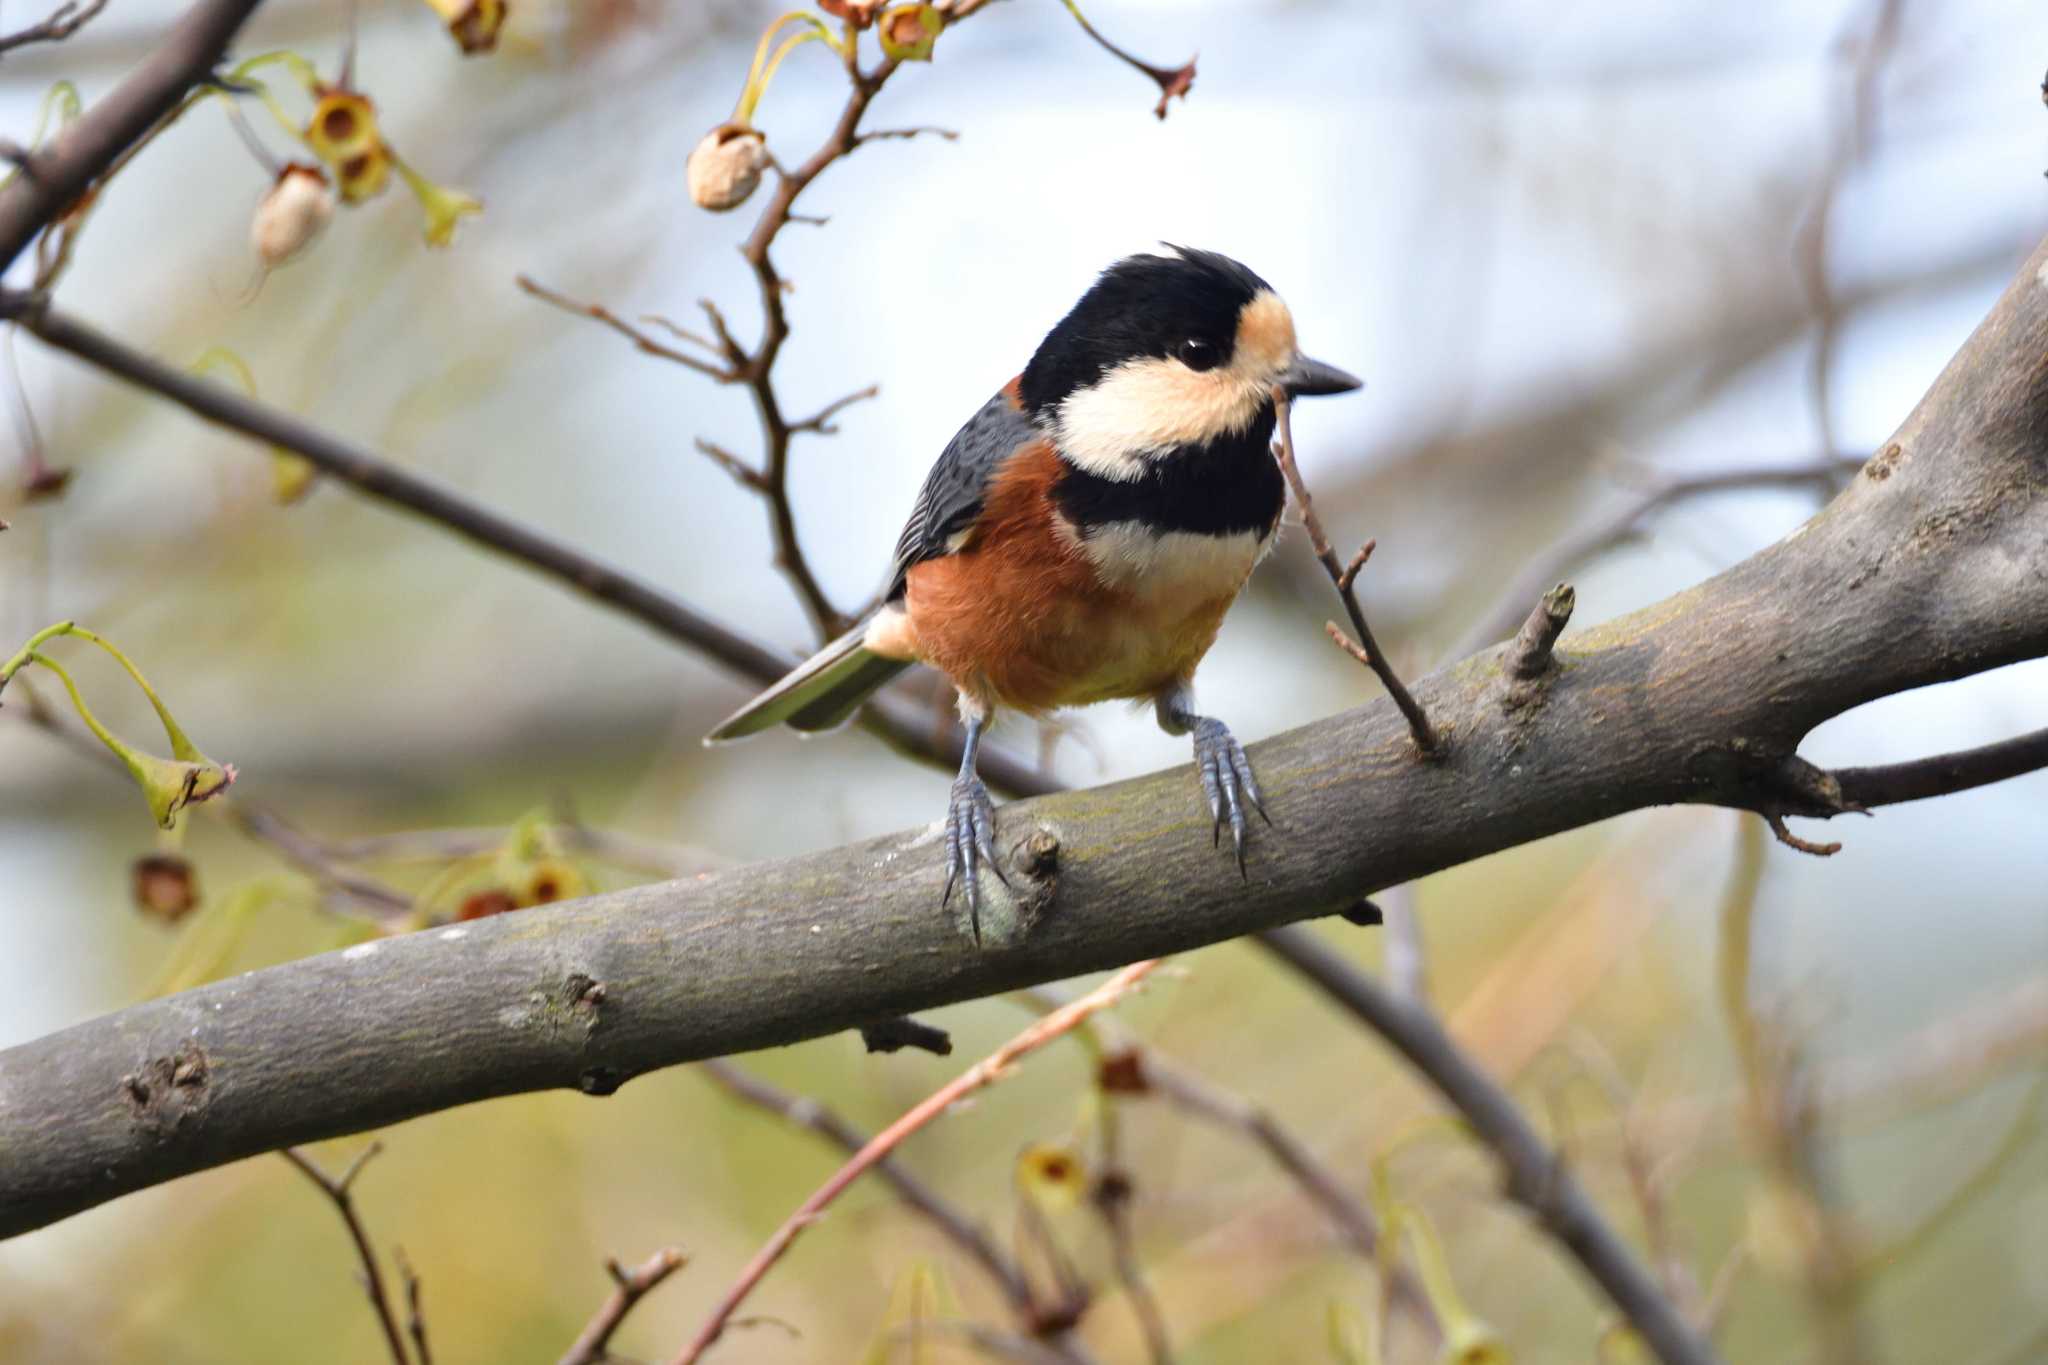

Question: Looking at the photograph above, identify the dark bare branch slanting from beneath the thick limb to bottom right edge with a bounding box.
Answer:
[1264,933,1716,1365]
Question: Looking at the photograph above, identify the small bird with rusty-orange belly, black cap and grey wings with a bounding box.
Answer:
[705,244,1362,941]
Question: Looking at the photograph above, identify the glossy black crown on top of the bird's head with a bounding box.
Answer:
[1022,244,1272,415]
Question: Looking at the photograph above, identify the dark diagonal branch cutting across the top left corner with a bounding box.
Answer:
[0,0,262,270]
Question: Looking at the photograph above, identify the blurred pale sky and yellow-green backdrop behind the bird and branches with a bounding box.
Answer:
[0,0,2048,1365]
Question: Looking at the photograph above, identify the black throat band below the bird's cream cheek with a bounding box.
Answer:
[1053,403,1286,536]
